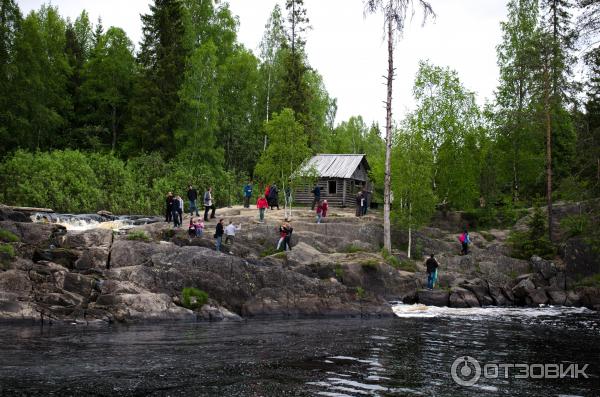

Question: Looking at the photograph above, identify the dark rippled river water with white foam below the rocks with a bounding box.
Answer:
[0,306,600,396]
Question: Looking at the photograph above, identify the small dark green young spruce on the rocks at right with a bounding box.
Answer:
[508,207,556,259]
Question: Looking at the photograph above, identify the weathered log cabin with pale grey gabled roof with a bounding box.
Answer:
[294,154,372,207]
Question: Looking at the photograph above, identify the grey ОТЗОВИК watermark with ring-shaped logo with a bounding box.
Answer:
[450,356,589,386]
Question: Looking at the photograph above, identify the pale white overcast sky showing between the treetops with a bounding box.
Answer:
[17,0,506,126]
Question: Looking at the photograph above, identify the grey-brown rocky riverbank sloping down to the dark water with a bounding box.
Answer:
[0,203,600,323]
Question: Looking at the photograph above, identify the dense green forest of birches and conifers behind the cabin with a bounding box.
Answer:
[0,0,600,226]
